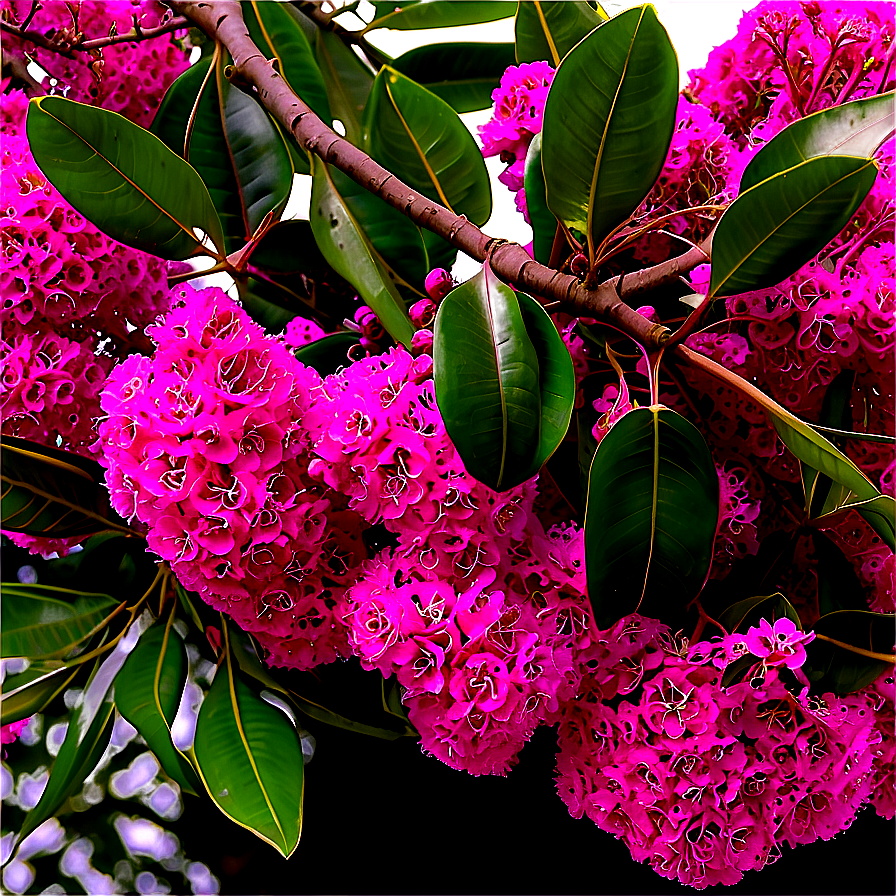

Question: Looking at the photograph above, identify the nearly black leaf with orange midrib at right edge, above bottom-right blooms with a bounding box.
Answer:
[803,610,896,696]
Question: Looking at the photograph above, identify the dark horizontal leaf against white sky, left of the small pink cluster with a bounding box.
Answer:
[392,42,516,113]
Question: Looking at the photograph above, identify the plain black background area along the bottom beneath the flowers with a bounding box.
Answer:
[170,723,896,896]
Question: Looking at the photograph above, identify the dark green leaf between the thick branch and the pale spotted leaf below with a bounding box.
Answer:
[329,168,429,292]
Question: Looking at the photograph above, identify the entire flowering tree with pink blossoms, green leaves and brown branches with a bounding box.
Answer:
[0,0,896,888]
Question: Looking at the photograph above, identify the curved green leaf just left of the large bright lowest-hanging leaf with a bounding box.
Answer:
[115,617,201,796]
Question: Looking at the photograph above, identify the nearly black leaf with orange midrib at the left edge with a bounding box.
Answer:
[0,436,131,538]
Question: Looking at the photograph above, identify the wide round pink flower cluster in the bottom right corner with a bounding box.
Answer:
[557,616,892,889]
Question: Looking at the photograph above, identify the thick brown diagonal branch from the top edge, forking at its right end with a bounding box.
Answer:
[168,0,707,349]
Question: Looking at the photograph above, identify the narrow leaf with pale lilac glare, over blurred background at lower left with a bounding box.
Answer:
[17,655,121,843]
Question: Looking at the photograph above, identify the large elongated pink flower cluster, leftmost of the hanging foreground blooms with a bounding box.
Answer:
[96,286,364,668]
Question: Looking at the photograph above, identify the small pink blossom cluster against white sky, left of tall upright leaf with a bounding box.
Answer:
[479,62,554,220]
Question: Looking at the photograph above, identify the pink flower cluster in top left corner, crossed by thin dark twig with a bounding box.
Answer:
[0,0,189,127]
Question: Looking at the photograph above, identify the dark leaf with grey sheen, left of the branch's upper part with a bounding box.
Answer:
[215,51,292,240]
